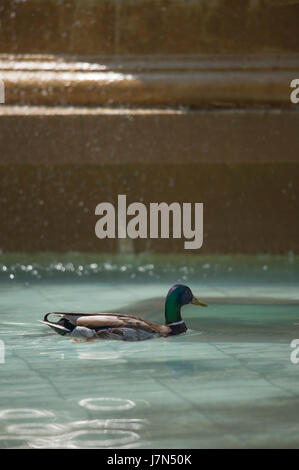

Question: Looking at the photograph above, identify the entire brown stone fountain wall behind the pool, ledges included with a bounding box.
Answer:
[0,0,299,253]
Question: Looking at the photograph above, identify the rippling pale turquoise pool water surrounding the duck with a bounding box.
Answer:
[0,254,299,448]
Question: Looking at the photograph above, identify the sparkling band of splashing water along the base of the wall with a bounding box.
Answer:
[0,251,299,285]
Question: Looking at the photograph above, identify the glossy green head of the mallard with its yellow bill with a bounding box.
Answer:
[165,284,207,325]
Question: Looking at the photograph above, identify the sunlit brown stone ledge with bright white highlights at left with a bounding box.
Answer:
[0,54,299,108]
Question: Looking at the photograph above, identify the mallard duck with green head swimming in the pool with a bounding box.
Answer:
[41,284,207,341]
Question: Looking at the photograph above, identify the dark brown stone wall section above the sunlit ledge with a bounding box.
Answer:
[0,0,299,55]
